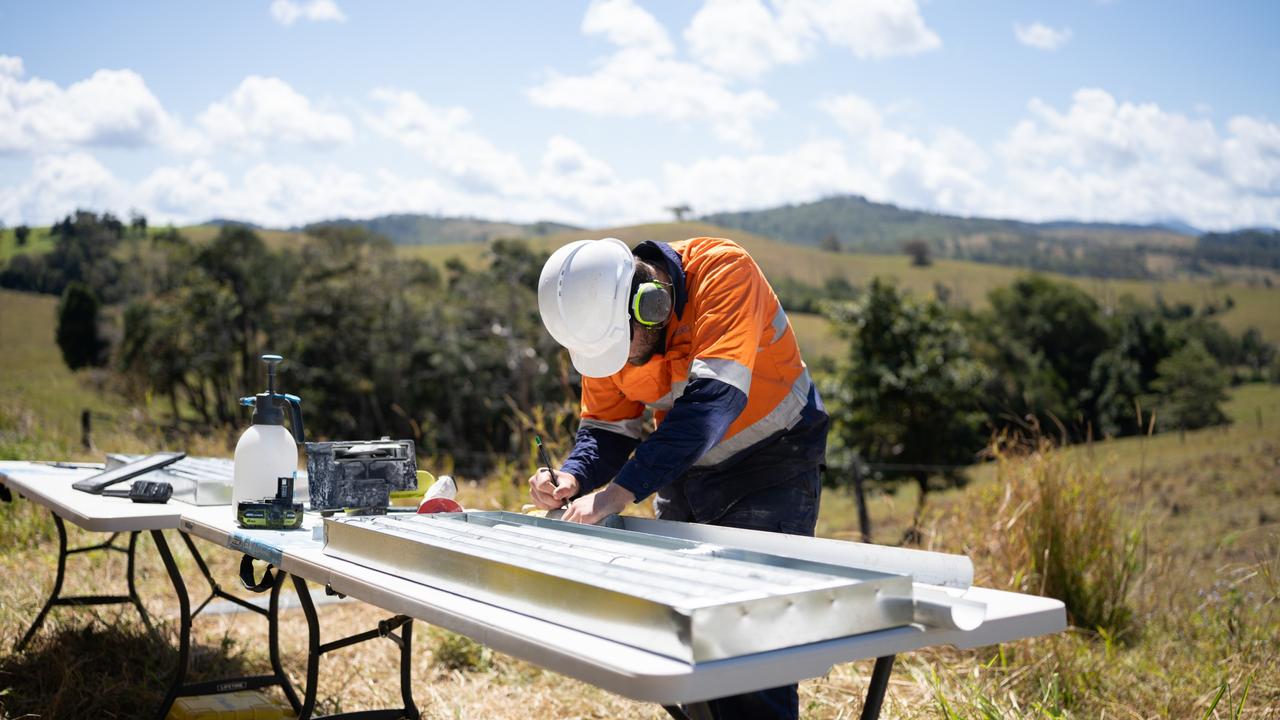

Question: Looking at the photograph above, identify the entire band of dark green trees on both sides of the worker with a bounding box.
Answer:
[0,211,1276,489]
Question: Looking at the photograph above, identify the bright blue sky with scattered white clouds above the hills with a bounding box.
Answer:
[0,0,1280,229]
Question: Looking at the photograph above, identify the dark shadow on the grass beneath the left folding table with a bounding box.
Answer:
[0,624,257,720]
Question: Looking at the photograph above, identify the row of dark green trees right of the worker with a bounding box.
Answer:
[823,275,1280,495]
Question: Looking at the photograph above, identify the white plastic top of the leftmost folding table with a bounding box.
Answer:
[0,461,193,533]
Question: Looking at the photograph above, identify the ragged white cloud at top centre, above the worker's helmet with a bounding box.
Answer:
[529,0,777,146]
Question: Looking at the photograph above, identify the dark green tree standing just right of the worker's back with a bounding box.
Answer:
[827,278,989,515]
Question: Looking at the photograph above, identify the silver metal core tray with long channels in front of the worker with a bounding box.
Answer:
[324,511,914,662]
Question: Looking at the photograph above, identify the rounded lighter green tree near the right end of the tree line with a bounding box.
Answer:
[1152,340,1228,430]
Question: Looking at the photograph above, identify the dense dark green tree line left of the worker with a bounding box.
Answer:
[0,211,577,471]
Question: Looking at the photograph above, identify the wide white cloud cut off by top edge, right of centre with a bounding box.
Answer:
[685,0,942,77]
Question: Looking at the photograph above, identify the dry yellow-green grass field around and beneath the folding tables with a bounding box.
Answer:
[0,283,1280,720]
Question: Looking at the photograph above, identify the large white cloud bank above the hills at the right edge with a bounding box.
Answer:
[993,88,1280,228]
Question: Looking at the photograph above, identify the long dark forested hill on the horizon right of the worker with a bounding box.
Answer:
[701,195,1196,278]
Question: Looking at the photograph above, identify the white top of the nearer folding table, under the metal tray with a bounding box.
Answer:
[180,506,1066,705]
